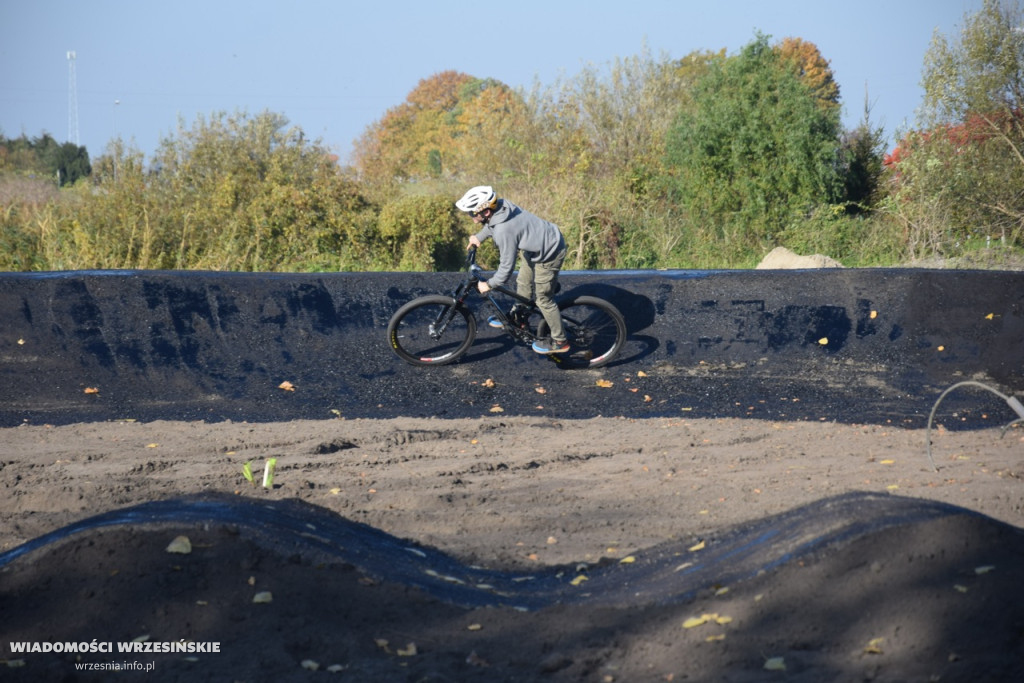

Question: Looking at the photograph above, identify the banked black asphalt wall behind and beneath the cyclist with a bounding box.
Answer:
[0,269,1024,427]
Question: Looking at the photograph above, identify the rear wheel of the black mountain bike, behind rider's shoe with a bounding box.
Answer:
[537,296,626,368]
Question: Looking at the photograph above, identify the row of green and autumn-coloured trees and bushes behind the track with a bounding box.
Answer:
[0,0,1024,271]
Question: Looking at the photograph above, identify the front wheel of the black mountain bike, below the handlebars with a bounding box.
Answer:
[387,295,476,366]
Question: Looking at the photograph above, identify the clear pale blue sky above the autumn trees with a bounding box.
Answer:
[0,0,982,165]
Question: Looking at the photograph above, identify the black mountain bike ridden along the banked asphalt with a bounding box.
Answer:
[387,247,626,368]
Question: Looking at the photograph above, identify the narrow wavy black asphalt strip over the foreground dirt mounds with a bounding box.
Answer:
[0,493,1024,609]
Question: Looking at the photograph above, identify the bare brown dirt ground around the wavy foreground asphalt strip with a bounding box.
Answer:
[0,415,1024,683]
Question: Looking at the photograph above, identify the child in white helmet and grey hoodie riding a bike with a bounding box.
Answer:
[455,185,569,353]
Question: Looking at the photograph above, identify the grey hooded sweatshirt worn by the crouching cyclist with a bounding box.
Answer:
[476,200,565,287]
